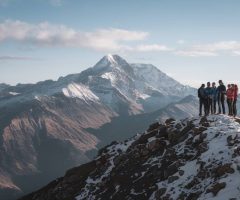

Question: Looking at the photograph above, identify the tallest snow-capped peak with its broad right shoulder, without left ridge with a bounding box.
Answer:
[74,55,196,112]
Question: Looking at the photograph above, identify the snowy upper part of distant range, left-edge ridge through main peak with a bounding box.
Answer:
[0,54,196,115]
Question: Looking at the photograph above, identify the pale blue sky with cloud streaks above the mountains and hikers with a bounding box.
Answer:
[0,0,240,87]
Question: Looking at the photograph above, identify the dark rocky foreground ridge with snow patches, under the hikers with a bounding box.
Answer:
[21,115,240,200]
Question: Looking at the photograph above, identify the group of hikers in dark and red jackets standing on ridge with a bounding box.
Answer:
[198,80,238,117]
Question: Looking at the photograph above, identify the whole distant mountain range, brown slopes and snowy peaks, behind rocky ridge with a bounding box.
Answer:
[0,55,198,200]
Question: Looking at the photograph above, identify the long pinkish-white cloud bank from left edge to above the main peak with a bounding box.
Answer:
[0,20,170,52]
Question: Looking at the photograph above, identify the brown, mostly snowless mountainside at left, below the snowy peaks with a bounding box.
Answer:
[0,95,117,199]
